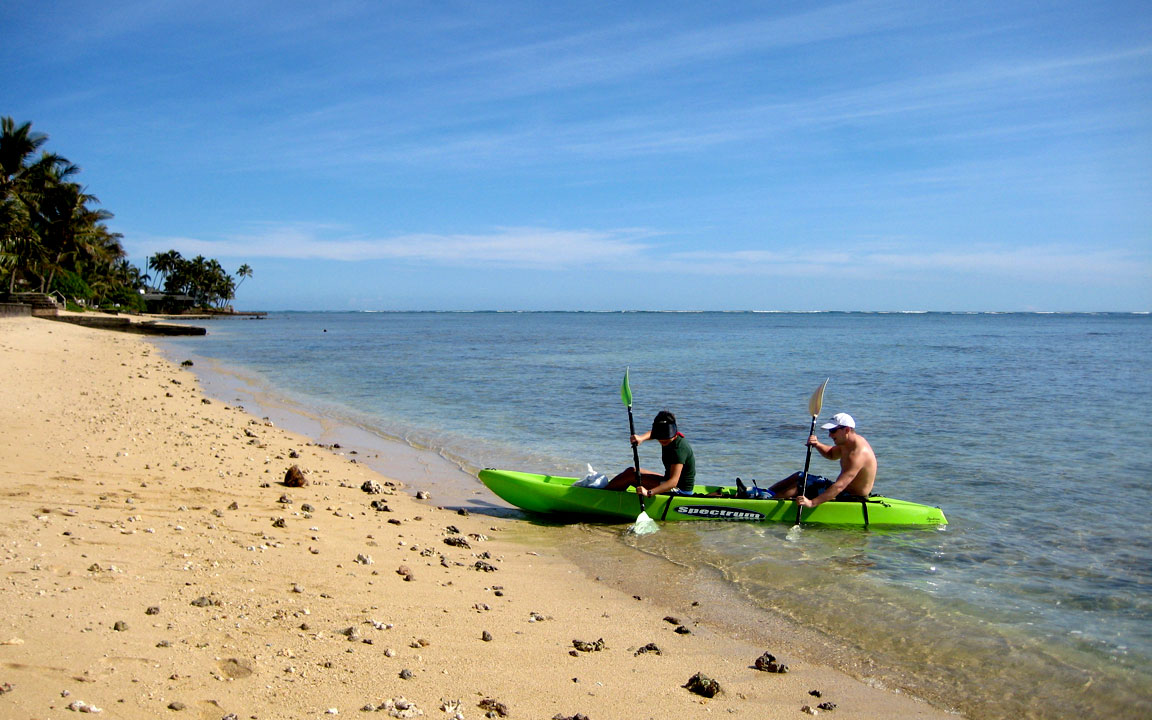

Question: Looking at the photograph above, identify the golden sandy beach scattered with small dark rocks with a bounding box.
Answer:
[0,318,956,720]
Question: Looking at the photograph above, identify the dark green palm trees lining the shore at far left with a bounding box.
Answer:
[0,118,252,310]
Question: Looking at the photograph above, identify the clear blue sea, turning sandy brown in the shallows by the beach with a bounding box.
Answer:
[157,313,1152,718]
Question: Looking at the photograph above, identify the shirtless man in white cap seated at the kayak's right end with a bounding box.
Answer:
[771,412,877,508]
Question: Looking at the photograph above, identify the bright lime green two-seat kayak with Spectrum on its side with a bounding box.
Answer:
[479,469,948,526]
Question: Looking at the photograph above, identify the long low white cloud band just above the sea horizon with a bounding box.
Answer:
[132,225,1152,285]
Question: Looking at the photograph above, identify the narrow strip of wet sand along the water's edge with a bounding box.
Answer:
[160,341,962,717]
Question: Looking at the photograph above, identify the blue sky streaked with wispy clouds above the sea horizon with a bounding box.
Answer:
[0,0,1152,311]
